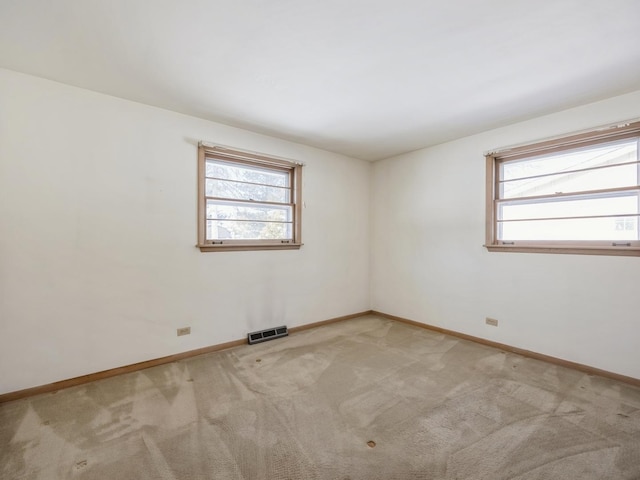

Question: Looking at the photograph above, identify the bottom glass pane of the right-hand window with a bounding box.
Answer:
[498,217,638,241]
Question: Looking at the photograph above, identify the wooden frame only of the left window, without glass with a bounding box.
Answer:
[196,142,303,252]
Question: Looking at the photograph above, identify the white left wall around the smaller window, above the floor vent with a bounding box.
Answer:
[0,70,370,393]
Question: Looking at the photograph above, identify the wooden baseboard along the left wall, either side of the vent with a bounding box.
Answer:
[0,310,371,403]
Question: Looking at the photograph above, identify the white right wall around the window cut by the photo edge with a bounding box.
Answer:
[371,91,640,378]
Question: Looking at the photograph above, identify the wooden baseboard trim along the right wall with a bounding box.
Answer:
[371,310,640,387]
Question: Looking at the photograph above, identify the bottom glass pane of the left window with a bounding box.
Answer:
[207,220,293,240]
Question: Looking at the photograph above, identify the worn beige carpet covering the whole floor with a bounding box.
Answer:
[0,316,640,480]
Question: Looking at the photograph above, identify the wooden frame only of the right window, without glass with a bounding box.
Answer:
[484,121,640,256]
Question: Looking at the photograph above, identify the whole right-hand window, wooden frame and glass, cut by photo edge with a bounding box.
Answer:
[485,122,640,256]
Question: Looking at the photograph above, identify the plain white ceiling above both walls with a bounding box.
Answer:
[0,0,640,160]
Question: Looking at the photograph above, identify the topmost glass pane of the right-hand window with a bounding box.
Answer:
[500,138,638,184]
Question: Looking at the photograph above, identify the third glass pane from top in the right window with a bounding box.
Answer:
[498,194,640,220]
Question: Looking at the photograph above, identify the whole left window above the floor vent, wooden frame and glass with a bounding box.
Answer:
[198,143,302,252]
